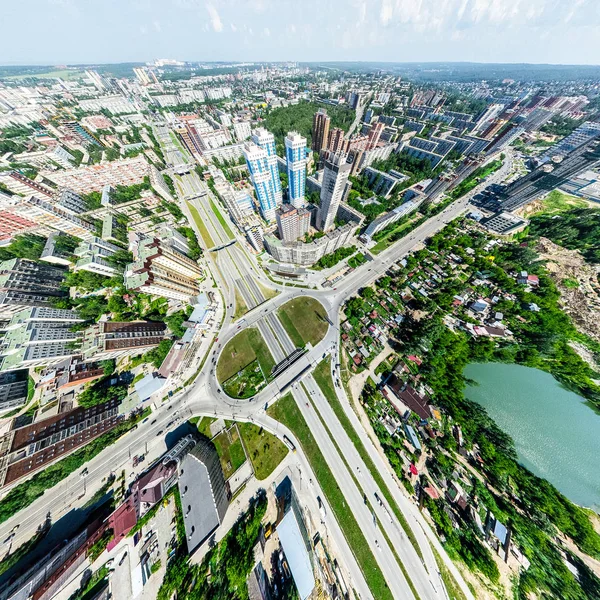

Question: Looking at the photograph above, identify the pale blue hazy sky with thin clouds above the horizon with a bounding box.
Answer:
[0,0,600,65]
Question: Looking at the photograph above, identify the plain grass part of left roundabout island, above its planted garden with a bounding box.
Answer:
[217,327,275,383]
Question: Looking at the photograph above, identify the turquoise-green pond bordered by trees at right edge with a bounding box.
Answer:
[464,363,600,510]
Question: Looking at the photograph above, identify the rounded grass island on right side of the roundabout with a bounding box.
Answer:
[278,296,329,348]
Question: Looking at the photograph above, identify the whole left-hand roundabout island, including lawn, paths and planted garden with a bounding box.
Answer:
[217,327,275,398]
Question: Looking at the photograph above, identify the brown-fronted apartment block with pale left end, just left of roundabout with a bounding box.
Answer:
[80,321,167,361]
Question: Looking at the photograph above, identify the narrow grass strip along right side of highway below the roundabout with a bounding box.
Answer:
[313,358,423,560]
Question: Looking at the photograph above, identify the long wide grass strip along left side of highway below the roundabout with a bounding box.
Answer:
[267,394,393,600]
